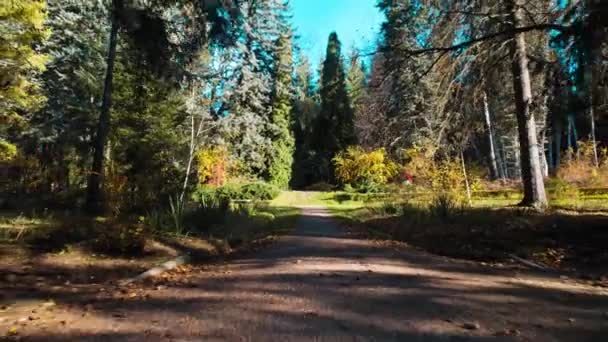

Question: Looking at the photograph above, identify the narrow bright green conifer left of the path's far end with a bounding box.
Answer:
[267,35,295,189]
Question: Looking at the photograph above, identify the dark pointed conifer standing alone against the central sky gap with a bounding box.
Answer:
[314,32,356,181]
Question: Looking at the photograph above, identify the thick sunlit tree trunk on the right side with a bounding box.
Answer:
[509,0,548,210]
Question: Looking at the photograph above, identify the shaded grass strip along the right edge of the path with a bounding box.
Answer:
[333,203,608,275]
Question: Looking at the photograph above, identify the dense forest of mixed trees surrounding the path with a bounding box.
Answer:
[0,0,608,213]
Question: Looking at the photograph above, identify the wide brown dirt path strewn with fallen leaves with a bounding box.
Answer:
[0,207,608,342]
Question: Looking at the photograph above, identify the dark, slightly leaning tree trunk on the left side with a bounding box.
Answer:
[87,0,122,213]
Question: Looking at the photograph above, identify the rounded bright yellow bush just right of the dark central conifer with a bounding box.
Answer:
[333,146,399,187]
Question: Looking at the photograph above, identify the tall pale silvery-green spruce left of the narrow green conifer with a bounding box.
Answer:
[226,0,289,178]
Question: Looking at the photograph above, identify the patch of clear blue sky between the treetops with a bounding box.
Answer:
[291,0,383,67]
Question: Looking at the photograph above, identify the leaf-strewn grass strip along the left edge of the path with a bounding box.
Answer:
[0,202,299,281]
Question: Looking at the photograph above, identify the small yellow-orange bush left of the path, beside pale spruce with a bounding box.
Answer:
[196,147,229,186]
